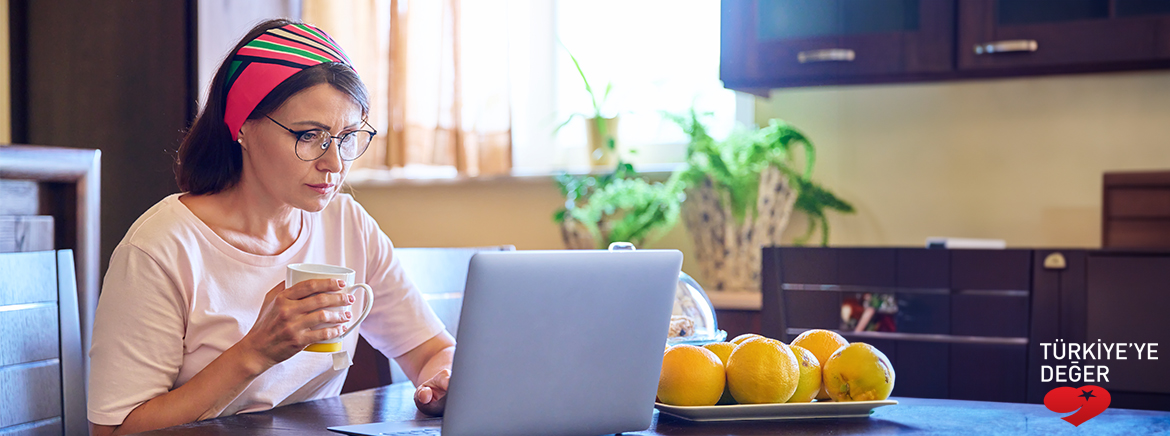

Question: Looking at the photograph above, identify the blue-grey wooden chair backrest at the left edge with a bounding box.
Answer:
[0,250,89,435]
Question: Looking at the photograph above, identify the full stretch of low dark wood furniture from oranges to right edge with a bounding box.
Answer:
[761,247,1170,410]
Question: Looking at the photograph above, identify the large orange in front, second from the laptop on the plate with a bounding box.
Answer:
[727,337,800,404]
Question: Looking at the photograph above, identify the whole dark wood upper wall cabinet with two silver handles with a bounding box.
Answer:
[720,0,1170,90]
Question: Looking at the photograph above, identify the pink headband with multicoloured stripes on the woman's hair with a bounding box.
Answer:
[223,23,353,140]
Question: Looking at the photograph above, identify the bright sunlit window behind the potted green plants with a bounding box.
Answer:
[509,0,734,172]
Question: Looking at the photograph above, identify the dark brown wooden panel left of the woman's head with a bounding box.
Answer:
[19,0,195,271]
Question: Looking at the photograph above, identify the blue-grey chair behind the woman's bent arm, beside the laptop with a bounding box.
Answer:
[342,245,516,393]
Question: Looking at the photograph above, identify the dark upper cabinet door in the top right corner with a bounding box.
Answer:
[959,0,1170,72]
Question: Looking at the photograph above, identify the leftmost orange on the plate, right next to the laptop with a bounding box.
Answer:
[658,345,727,406]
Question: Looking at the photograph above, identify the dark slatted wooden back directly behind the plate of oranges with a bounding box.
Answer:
[762,247,1032,402]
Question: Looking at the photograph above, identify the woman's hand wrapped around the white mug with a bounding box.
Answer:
[233,278,353,372]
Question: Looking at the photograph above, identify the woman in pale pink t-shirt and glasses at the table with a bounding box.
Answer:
[88,20,455,435]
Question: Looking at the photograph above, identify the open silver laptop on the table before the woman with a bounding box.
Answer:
[329,250,682,436]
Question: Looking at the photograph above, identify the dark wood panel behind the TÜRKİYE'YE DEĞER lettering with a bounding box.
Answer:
[1027,249,1170,410]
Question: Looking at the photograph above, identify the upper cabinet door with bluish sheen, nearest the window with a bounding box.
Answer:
[720,0,955,89]
